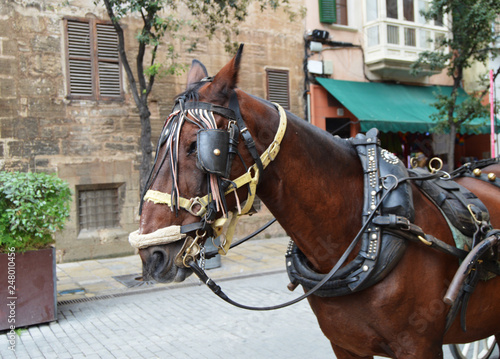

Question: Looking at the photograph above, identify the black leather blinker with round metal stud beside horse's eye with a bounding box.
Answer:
[197,129,229,177]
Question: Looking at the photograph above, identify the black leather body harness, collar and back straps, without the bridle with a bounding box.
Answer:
[286,129,500,331]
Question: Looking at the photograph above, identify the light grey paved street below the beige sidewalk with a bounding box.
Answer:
[0,272,498,359]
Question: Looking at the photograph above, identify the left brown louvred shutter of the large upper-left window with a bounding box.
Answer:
[67,20,93,97]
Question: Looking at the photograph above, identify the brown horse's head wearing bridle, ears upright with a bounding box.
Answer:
[129,46,284,282]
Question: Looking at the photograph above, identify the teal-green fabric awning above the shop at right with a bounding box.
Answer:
[316,77,490,133]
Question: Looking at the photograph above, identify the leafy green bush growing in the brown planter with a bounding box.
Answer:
[0,172,71,252]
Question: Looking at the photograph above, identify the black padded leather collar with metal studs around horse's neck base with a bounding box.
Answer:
[286,129,414,297]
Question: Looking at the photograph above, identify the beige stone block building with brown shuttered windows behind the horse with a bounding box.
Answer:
[0,0,304,261]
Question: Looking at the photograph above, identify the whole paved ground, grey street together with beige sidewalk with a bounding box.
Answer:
[0,238,498,359]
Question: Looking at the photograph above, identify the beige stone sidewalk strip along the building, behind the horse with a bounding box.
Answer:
[57,237,289,304]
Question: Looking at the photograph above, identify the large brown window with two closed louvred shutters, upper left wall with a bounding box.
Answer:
[65,19,122,100]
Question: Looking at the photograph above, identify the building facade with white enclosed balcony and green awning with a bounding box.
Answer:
[304,0,489,169]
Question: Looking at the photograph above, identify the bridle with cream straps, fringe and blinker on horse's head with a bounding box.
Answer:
[129,92,287,267]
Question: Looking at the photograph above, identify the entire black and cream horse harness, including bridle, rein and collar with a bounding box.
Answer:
[129,91,500,327]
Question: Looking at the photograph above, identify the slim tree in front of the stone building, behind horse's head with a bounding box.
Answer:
[96,0,296,191]
